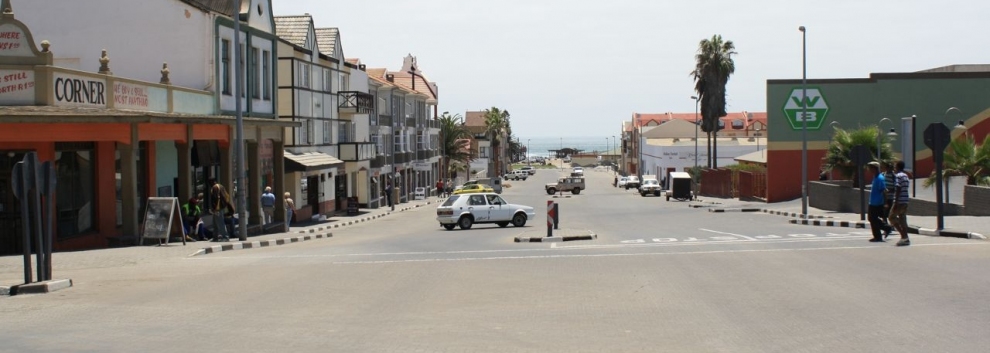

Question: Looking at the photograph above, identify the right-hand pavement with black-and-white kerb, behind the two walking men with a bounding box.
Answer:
[689,195,990,239]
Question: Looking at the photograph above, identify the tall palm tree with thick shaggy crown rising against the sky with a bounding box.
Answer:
[691,34,736,168]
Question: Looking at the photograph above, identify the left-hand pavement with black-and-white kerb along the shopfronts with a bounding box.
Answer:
[0,197,440,292]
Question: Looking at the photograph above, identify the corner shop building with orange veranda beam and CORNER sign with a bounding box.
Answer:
[0,0,290,252]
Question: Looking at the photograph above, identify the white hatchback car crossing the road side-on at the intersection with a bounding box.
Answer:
[437,192,536,230]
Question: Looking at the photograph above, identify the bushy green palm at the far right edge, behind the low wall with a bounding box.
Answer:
[925,135,990,187]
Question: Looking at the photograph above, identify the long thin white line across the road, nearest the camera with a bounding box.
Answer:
[332,242,988,265]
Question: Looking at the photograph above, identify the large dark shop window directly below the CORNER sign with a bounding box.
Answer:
[55,143,96,239]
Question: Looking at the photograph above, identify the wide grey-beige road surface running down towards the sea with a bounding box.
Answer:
[0,166,990,352]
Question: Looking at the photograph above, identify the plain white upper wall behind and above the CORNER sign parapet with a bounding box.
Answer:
[17,0,213,89]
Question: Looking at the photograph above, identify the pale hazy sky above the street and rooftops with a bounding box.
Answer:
[272,0,990,138]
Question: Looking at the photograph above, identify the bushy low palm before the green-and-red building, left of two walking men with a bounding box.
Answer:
[822,126,894,187]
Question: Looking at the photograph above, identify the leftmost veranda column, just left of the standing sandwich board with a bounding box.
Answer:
[117,124,141,240]
